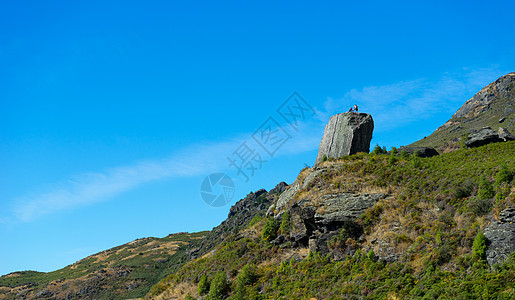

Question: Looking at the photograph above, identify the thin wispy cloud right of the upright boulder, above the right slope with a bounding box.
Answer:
[325,67,507,131]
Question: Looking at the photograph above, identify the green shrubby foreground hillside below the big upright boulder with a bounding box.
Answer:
[147,142,515,299]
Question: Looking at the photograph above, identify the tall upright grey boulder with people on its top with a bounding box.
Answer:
[316,112,374,164]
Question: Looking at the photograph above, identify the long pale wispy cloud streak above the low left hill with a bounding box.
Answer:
[13,141,235,222]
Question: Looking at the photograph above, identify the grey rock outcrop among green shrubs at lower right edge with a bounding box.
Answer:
[485,207,515,266]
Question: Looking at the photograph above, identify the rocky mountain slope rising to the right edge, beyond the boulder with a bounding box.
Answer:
[412,72,515,152]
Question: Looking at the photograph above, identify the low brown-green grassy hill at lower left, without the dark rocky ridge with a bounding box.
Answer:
[0,232,206,299]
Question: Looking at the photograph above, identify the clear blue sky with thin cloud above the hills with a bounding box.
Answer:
[0,1,515,274]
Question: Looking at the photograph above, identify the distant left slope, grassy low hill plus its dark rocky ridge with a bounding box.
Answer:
[0,182,288,299]
